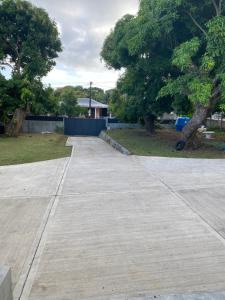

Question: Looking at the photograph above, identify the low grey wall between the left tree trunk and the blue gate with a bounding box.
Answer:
[23,120,64,133]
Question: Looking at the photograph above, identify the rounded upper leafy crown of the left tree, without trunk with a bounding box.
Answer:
[0,0,62,80]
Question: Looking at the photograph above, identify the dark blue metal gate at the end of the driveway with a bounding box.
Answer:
[64,118,106,136]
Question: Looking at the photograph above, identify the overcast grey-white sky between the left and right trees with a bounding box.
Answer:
[30,0,139,90]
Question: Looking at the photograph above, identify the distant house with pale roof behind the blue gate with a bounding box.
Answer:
[77,98,109,119]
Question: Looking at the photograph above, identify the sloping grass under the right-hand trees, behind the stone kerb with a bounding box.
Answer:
[108,129,225,158]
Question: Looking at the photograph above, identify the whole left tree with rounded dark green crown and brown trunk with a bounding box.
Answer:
[0,0,62,136]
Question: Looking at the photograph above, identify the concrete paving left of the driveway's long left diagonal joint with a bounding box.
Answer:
[0,158,69,296]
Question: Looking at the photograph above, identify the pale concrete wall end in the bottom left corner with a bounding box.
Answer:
[0,267,13,300]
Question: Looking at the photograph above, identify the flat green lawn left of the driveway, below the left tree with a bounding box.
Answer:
[0,134,71,166]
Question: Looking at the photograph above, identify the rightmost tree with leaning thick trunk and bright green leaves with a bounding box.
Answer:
[157,0,225,150]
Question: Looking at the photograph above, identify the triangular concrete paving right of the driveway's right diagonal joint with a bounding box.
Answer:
[138,157,225,238]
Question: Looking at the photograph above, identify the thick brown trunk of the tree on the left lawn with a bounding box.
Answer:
[6,108,27,137]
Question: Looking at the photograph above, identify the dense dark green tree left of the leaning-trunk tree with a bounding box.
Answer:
[101,4,187,133]
